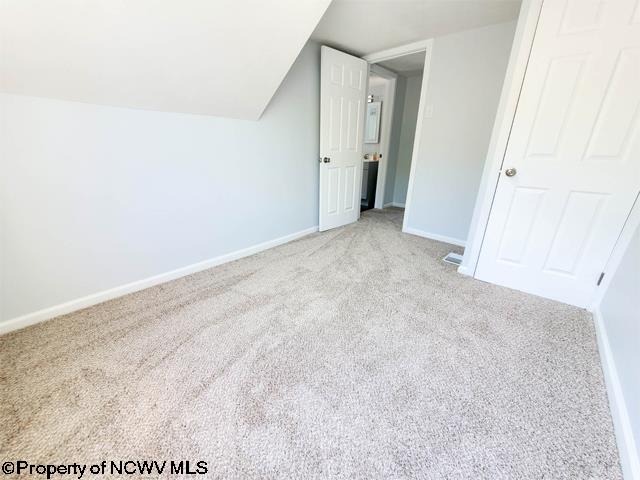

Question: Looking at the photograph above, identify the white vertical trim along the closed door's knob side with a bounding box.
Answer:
[458,0,543,276]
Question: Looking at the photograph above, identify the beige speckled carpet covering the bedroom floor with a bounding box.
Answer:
[0,210,621,479]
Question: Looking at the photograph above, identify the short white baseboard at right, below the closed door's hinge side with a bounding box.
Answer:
[592,308,640,480]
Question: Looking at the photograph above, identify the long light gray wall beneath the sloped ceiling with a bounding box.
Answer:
[0,43,320,320]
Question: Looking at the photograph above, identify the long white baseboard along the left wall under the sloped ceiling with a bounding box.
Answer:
[0,226,318,335]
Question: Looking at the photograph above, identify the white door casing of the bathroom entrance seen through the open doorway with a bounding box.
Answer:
[367,65,398,208]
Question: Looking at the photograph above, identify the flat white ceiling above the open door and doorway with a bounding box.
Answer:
[312,0,520,55]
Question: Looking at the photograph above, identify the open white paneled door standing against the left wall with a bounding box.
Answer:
[319,46,368,231]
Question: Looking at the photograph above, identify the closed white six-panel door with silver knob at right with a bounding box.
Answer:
[476,0,640,307]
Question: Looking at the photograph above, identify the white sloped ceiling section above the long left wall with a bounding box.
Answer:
[0,0,330,120]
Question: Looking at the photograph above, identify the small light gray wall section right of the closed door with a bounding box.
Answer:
[600,223,640,456]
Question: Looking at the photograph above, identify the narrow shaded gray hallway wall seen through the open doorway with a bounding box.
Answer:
[393,74,422,203]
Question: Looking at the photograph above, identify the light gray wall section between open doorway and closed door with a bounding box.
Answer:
[407,22,516,241]
